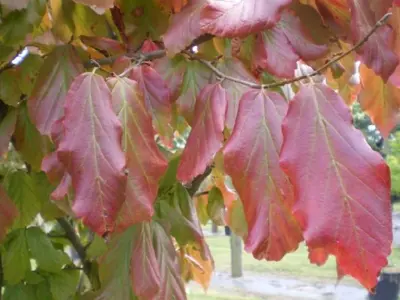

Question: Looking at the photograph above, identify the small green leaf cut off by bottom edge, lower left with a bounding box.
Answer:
[49,270,79,300]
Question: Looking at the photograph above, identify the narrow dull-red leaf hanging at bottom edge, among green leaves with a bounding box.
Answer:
[131,223,165,299]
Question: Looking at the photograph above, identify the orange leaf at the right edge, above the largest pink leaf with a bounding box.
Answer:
[358,65,400,137]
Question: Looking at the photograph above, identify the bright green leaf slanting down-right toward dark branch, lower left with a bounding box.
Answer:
[26,227,69,273]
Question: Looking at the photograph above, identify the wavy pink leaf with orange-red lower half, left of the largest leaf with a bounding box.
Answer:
[223,90,303,261]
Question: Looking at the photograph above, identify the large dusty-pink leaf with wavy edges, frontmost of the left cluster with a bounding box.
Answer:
[57,73,126,235]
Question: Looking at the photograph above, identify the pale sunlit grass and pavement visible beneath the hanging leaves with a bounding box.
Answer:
[188,221,400,300]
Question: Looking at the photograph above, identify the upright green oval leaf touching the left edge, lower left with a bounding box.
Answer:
[2,229,30,284]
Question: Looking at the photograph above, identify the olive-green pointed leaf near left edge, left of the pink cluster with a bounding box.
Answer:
[14,102,51,172]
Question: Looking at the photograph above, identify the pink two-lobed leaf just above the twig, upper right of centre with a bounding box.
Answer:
[253,11,328,78]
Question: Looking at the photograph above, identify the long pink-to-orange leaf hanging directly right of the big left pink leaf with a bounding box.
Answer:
[108,78,168,229]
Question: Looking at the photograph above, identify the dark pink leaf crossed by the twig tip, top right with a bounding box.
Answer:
[349,0,399,82]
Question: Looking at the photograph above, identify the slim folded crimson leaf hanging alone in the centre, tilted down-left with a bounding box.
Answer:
[177,83,227,183]
